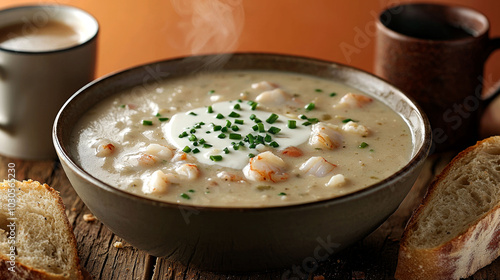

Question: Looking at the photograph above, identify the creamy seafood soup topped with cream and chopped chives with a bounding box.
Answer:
[72,71,412,207]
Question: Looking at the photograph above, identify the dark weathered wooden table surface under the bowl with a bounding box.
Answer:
[0,153,500,280]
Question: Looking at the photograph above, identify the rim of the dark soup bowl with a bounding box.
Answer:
[52,52,432,212]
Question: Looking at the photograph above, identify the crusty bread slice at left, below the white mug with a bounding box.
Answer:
[0,180,83,280]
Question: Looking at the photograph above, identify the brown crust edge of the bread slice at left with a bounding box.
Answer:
[0,180,83,280]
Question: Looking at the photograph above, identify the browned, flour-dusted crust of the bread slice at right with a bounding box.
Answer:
[394,136,500,280]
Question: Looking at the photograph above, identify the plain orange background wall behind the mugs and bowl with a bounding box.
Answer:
[0,0,500,85]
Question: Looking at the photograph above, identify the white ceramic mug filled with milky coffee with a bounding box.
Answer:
[0,5,99,159]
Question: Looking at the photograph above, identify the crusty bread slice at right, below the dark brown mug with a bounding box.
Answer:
[395,136,500,280]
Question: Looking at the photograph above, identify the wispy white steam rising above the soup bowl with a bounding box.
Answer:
[171,0,245,67]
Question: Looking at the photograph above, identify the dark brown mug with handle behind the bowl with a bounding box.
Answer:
[375,4,500,151]
